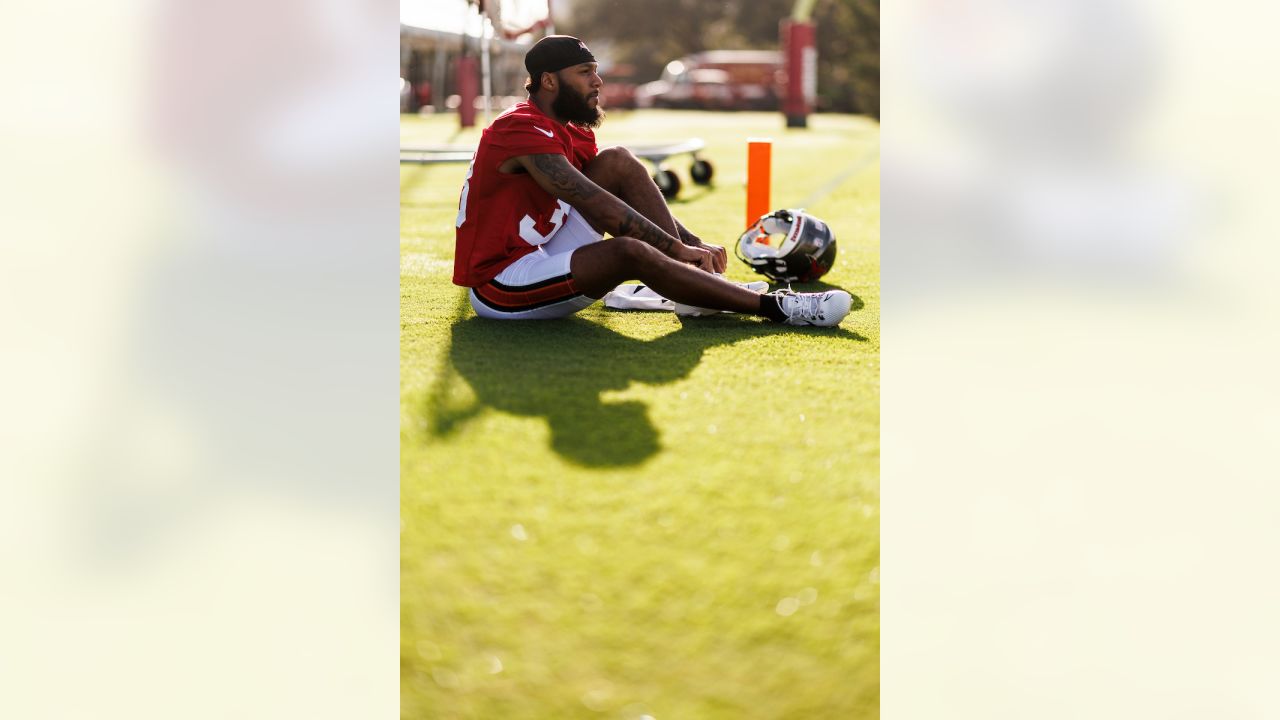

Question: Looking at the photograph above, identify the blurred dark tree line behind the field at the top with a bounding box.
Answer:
[556,0,879,119]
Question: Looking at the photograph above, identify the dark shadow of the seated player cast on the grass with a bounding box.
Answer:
[425,307,867,468]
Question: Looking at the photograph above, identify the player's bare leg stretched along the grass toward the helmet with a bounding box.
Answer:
[570,237,760,314]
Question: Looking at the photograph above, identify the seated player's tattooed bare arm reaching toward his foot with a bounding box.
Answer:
[516,154,713,269]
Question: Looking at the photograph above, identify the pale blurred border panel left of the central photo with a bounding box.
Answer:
[0,0,399,717]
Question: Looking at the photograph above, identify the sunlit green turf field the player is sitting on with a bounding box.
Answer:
[401,111,879,720]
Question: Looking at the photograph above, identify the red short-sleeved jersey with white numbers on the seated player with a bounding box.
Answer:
[453,101,596,287]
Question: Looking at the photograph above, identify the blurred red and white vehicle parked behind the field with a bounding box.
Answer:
[635,50,786,110]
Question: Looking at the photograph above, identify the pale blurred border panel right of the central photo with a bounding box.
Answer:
[881,0,1280,719]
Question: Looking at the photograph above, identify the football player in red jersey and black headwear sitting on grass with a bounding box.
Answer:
[453,35,851,325]
